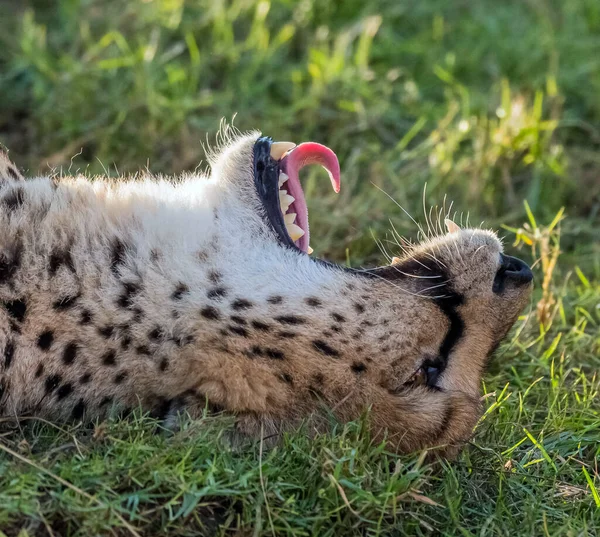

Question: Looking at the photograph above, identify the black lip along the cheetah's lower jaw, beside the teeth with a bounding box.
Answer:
[254,136,304,253]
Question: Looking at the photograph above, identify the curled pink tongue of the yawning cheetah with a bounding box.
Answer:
[280,142,340,252]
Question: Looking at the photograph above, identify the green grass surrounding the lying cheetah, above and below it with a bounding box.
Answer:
[0,0,600,537]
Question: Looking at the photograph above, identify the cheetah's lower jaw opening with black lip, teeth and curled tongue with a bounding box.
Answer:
[254,137,340,254]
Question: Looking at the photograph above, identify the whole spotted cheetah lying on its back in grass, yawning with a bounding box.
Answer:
[0,127,533,456]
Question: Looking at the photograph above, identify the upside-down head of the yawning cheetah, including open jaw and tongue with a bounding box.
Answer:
[205,134,533,454]
